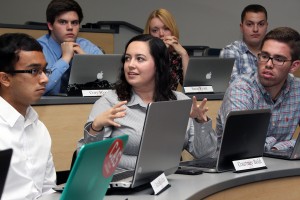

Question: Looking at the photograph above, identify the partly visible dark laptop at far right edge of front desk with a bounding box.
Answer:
[264,135,300,160]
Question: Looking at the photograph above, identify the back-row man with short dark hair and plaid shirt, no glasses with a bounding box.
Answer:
[220,4,268,82]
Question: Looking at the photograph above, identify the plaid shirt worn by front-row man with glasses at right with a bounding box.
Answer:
[216,73,300,149]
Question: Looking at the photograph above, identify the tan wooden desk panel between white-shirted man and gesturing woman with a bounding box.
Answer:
[34,104,93,171]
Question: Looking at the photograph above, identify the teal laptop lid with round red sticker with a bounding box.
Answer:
[60,135,128,200]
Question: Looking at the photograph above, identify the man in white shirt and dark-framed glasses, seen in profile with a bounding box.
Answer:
[0,33,56,199]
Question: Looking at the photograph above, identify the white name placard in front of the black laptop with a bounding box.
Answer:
[232,157,266,171]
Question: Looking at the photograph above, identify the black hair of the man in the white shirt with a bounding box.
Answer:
[0,33,43,72]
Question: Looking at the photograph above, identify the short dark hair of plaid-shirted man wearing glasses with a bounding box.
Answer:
[261,27,300,61]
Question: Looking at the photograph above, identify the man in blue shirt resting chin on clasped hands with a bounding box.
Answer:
[38,0,103,95]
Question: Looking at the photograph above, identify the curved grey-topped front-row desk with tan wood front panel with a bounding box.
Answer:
[41,158,300,200]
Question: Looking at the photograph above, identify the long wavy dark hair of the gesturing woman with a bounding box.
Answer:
[115,34,176,102]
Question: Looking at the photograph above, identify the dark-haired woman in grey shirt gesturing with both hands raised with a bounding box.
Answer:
[79,34,216,169]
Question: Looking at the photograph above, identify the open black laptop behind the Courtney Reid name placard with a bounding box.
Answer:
[180,109,271,172]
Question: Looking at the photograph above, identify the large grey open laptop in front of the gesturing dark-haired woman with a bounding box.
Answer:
[110,99,192,188]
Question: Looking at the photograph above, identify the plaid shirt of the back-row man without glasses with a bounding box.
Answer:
[220,41,257,83]
